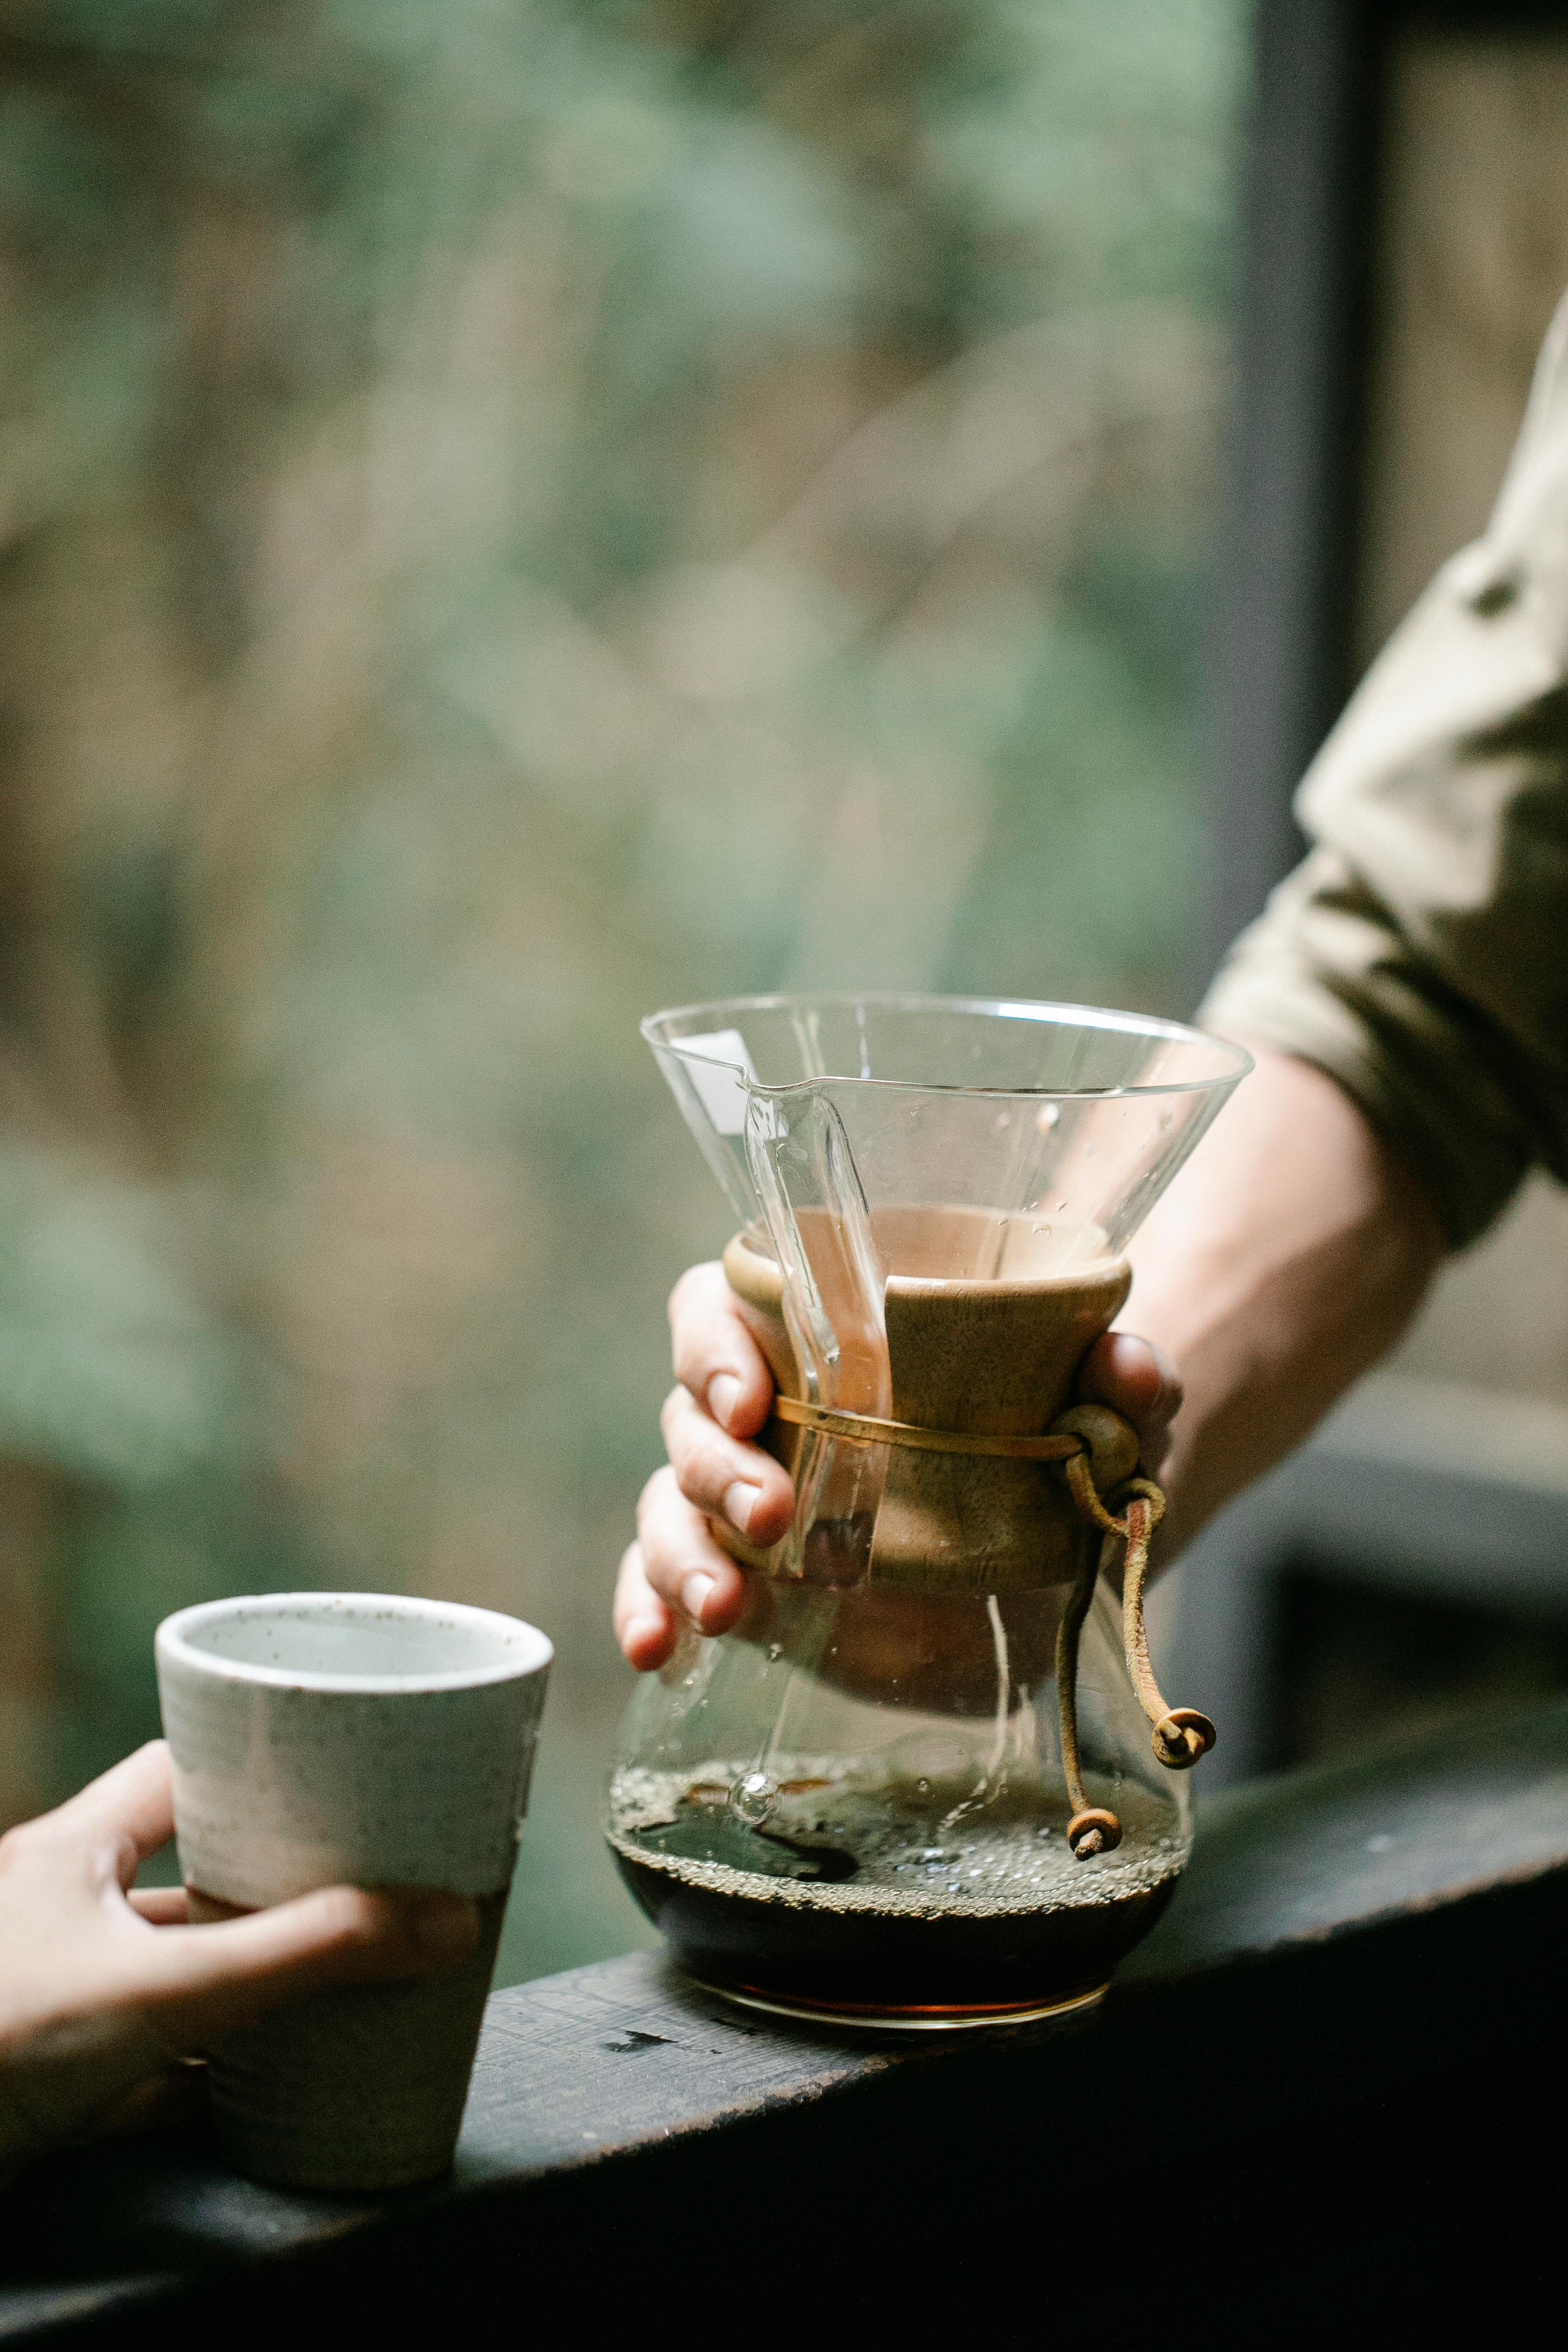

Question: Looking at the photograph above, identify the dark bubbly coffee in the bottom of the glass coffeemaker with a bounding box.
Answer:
[609,1759,1185,2020]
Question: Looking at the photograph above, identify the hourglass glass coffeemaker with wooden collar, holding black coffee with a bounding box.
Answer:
[607,995,1248,2027]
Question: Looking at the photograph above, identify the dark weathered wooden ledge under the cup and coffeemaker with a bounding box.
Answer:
[0,1705,1568,2352]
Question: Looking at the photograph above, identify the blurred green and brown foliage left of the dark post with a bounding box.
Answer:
[0,0,1244,1974]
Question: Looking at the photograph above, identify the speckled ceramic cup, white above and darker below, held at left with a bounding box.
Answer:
[158,1592,553,2190]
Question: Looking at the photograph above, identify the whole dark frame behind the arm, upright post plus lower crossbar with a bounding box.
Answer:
[1189,0,1568,1790]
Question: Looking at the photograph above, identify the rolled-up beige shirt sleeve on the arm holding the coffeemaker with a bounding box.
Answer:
[1201,301,1568,1244]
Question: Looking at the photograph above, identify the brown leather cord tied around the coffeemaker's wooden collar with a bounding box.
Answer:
[773,1397,1215,1863]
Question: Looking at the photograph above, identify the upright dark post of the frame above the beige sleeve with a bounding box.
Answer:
[1194,0,1568,995]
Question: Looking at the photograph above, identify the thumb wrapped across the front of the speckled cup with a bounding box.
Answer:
[132,1886,480,2046]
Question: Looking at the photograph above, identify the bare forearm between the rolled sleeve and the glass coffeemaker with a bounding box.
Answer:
[1121,1049,1443,1552]
